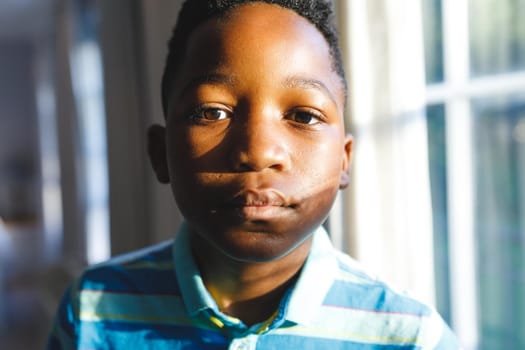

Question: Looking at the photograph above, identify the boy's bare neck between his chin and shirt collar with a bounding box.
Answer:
[192,234,312,326]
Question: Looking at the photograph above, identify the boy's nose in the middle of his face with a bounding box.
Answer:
[230,120,290,171]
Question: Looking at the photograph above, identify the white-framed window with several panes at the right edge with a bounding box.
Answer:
[423,0,525,349]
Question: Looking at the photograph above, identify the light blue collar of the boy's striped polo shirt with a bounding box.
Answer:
[173,223,337,324]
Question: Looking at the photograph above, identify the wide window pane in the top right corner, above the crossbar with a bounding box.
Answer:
[469,0,525,76]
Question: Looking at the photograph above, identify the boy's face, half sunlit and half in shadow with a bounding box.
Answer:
[154,3,351,261]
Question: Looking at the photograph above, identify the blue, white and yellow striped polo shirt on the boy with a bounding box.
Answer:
[48,224,459,350]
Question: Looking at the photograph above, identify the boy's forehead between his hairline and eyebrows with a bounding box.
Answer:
[170,3,344,107]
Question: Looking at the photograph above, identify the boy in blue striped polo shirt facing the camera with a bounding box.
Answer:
[49,0,458,349]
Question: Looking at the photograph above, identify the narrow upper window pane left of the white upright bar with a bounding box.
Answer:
[422,0,444,84]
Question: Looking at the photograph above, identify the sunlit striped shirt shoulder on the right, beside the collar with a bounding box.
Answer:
[296,250,458,349]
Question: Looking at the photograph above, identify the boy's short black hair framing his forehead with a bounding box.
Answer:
[161,0,347,116]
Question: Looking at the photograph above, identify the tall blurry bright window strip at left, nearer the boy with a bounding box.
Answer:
[70,0,110,264]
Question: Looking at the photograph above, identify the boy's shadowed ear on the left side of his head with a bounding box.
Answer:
[148,124,170,184]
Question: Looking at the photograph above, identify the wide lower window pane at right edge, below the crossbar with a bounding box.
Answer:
[472,94,525,350]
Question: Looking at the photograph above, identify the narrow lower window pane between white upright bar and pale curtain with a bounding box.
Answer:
[427,104,451,324]
